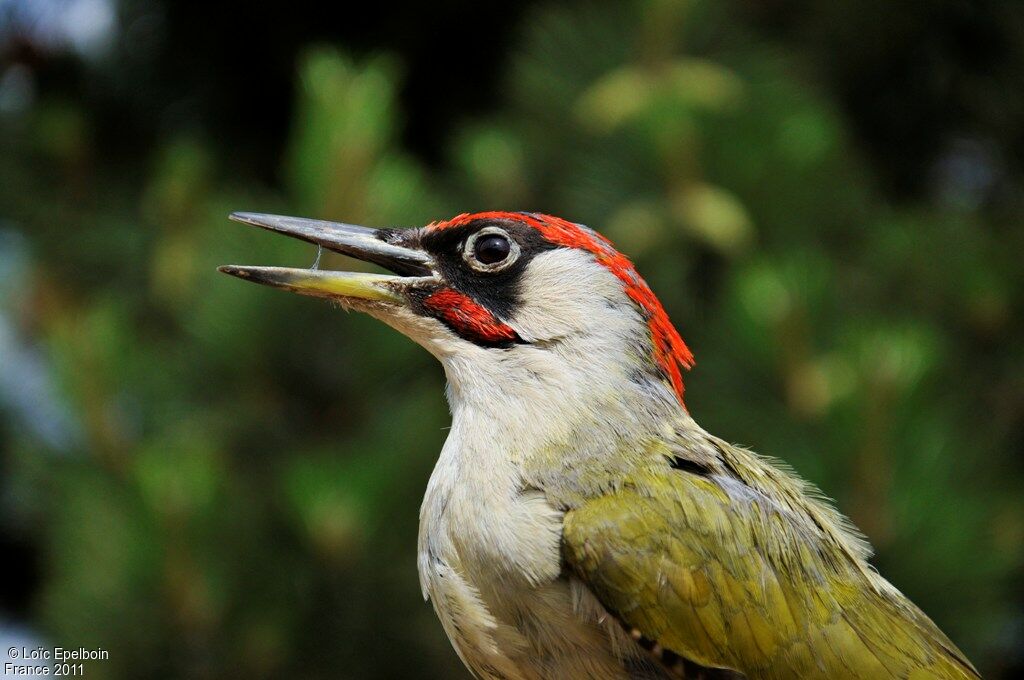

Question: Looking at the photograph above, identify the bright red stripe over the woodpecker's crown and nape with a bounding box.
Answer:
[428,212,693,408]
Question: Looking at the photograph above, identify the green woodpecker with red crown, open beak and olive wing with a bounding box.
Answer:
[221,212,979,680]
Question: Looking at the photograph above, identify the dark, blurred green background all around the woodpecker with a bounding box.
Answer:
[0,0,1024,679]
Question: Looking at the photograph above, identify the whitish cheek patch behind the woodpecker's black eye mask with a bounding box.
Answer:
[507,248,636,342]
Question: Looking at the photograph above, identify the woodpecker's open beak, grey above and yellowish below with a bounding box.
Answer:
[219,213,433,303]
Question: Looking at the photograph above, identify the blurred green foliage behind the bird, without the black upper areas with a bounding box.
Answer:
[0,0,1024,678]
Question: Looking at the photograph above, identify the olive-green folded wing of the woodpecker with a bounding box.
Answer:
[563,465,979,680]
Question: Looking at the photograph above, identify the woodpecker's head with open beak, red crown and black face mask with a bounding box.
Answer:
[220,212,693,409]
